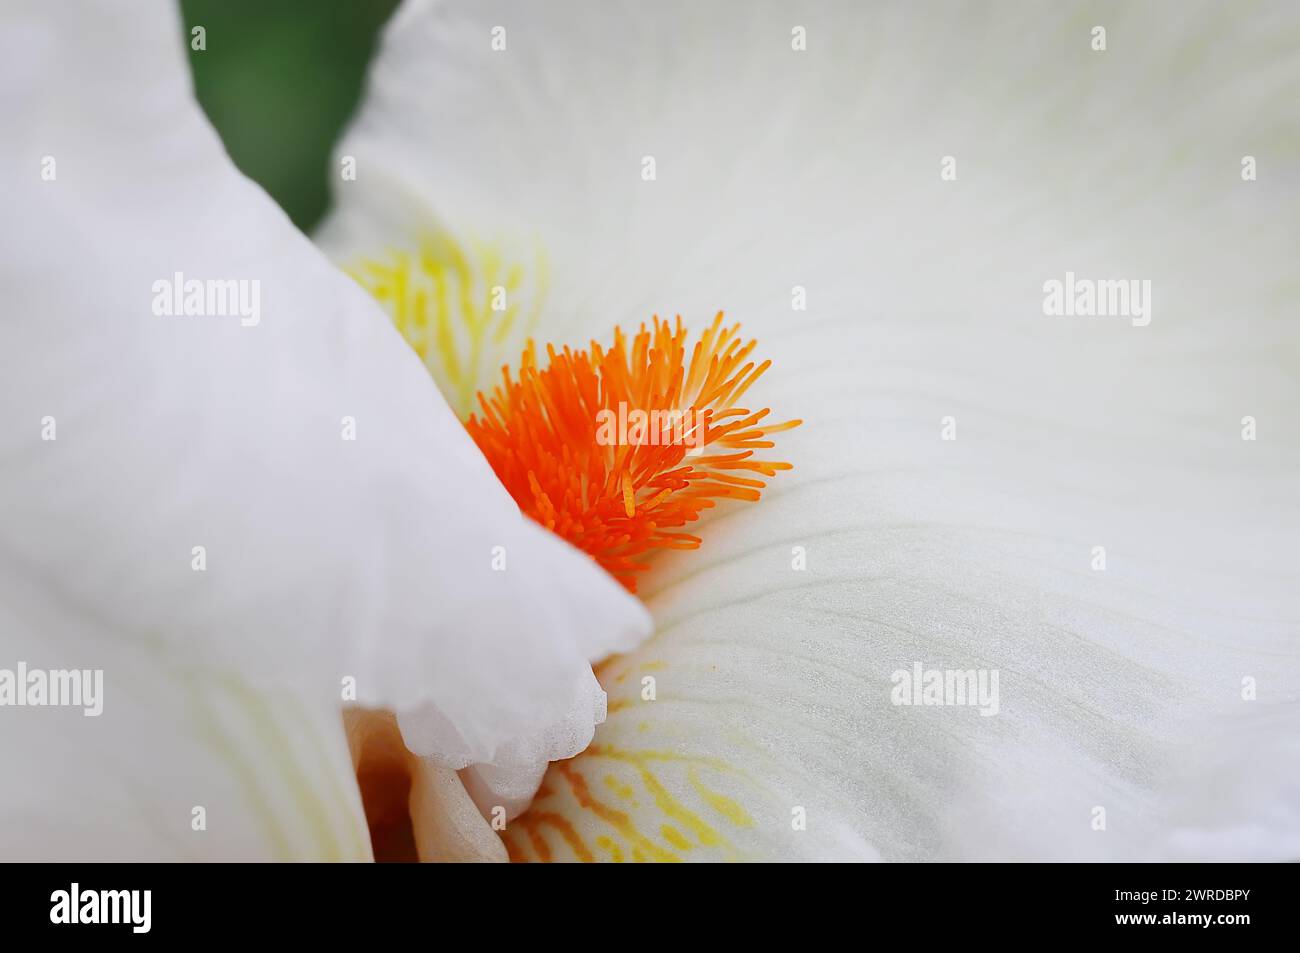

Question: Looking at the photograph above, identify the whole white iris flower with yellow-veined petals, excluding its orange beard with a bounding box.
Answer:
[0,0,1300,861]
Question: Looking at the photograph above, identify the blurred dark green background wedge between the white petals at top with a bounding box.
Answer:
[181,0,398,231]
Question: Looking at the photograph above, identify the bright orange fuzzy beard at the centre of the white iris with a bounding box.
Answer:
[465,312,801,592]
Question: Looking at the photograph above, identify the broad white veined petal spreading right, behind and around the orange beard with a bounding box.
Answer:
[324,1,1300,859]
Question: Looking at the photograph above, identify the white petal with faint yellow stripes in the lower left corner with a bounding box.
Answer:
[0,575,371,862]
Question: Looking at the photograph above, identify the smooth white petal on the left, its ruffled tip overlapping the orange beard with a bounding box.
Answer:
[0,3,649,852]
